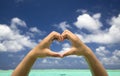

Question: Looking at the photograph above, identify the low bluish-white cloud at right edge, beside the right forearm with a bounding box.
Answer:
[95,46,120,66]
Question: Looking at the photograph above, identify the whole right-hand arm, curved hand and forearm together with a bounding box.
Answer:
[62,30,108,76]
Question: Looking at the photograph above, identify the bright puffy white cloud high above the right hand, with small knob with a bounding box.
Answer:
[74,13,102,32]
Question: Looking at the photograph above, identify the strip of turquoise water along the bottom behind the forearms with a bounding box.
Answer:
[0,69,120,76]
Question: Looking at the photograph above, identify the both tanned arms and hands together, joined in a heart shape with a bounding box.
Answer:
[12,30,108,76]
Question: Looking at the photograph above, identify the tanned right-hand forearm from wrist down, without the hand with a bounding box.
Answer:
[84,48,108,76]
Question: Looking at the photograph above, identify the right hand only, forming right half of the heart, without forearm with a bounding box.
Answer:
[62,30,88,56]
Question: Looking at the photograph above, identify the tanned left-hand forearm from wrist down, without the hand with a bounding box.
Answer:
[12,51,37,76]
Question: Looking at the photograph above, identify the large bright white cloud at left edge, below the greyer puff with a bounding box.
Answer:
[0,25,36,52]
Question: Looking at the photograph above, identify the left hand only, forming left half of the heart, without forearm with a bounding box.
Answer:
[29,31,63,58]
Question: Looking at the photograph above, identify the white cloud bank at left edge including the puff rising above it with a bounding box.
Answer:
[0,18,42,52]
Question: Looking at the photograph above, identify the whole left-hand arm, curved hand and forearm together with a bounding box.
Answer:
[12,31,62,76]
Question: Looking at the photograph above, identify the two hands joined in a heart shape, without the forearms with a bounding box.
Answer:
[32,30,86,57]
